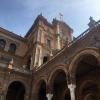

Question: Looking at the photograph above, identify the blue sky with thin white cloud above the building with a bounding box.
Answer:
[0,0,100,36]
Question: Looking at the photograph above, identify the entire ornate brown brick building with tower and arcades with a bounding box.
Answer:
[0,15,100,100]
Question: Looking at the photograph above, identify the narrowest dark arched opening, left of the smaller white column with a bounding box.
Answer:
[38,81,47,100]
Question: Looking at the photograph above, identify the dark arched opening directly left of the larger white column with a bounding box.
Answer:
[52,70,71,100]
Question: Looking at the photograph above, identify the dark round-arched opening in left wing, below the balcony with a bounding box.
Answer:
[6,81,25,100]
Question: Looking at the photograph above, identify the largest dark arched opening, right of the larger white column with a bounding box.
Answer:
[76,54,100,100]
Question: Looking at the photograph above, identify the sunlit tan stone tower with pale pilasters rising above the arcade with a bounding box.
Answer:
[25,14,73,69]
